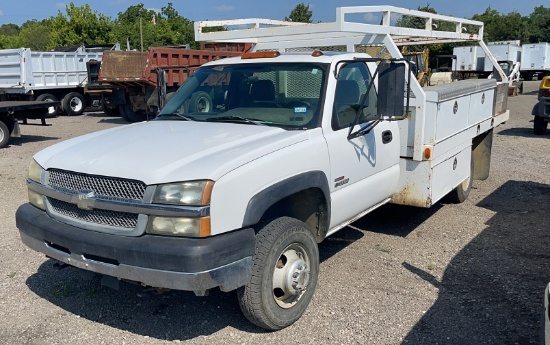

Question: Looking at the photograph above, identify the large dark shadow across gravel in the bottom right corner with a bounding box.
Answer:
[403,181,550,344]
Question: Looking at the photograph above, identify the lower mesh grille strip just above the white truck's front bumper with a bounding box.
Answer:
[48,198,138,228]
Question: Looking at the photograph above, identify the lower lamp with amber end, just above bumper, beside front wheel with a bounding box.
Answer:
[147,216,210,237]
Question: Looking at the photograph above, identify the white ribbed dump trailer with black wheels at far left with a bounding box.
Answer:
[0,48,103,115]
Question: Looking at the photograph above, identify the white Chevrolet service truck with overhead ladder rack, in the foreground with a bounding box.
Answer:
[16,6,509,330]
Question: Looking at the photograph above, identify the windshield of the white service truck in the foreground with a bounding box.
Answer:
[157,63,327,129]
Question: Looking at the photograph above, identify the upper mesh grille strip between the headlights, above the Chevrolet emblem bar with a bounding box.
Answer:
[47,169,147,201]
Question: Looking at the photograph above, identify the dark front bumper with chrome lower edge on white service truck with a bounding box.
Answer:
[15,204,255,293]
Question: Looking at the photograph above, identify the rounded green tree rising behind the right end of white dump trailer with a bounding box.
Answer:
[50,2,114,48]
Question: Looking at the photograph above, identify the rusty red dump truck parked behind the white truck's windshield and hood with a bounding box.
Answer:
[85,43,250,122]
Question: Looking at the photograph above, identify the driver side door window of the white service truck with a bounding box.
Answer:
[332,62,377,130]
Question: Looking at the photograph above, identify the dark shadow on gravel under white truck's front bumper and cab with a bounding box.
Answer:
[26,220,363,341]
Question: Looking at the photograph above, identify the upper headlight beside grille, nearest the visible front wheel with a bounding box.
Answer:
[153,181,214,205]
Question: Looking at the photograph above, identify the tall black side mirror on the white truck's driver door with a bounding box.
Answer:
[378,61,408,117]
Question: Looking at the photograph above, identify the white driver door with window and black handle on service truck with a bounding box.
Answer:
[325,62,403,228]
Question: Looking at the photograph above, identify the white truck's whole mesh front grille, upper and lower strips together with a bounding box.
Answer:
[46,170,147,229]
